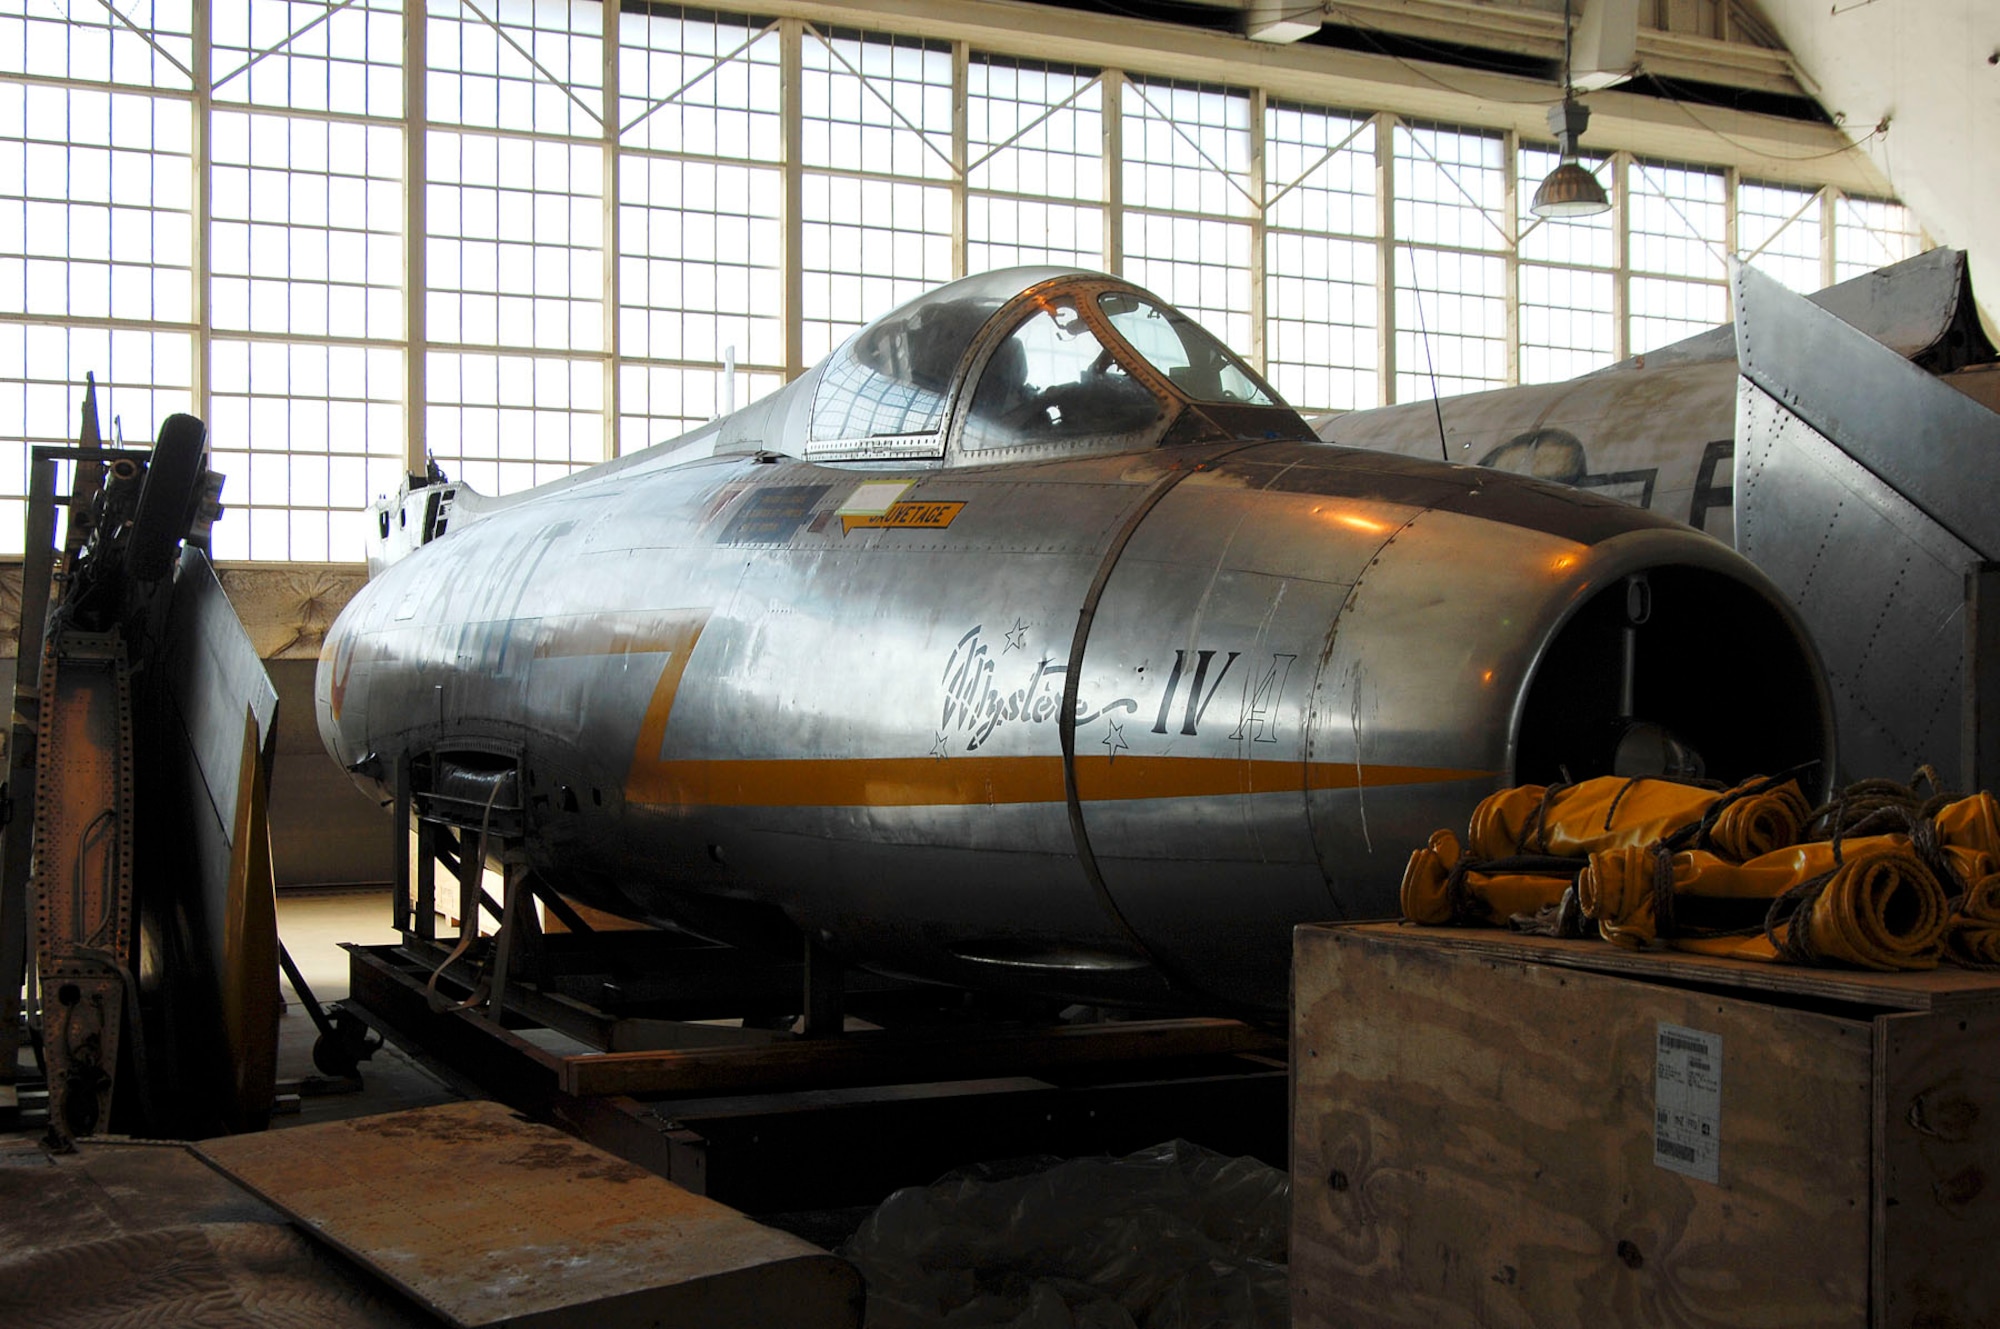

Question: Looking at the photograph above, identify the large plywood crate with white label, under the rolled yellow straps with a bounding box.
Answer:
[1292,925,2000,1329]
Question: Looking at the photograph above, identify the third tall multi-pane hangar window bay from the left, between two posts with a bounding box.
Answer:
[422,0,606,508]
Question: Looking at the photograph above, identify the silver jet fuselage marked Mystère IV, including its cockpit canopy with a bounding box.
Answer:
[318,272,1832,1009]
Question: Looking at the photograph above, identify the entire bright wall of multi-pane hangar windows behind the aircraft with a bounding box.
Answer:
[0,0,1928,558]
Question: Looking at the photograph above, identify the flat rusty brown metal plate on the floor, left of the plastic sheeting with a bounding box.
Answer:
[198,1103,862,1329]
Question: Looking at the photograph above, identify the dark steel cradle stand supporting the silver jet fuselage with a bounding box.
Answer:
[334,765,1286,1213]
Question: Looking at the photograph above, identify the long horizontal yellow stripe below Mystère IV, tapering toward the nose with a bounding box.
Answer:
[626,755,1494,807]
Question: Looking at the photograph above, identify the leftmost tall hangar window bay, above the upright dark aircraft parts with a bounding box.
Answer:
[0,33,198,550]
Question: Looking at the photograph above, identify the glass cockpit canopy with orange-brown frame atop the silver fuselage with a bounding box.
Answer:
[788,268,1314,464]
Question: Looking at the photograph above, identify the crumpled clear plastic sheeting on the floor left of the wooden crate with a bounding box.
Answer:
[840,1141,1290,1329]
